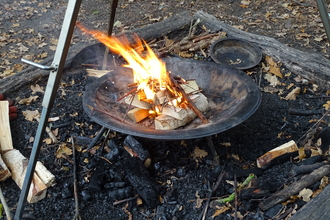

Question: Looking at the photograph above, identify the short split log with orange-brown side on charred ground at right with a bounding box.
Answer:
[257,141,298,169]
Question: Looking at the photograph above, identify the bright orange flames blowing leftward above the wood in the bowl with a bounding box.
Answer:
[77,23,170,100]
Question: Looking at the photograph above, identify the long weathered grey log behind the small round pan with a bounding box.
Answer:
[193,11,330,90]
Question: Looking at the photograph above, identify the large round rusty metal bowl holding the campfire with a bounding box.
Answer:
[83,58,261,140]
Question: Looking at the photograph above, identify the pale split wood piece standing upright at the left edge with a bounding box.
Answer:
[0,101,13,152]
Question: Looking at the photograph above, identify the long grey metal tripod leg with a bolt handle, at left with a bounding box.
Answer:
[14,0,82,220]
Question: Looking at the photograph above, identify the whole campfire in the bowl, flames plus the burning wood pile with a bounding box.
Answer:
[77,24,209,130]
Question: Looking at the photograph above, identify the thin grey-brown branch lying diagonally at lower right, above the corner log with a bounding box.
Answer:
[259,165,330,211]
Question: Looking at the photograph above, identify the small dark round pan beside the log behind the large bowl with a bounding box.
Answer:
[210,38,262,70]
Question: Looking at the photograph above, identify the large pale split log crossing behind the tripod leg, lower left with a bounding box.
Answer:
[2,149,47,203]
